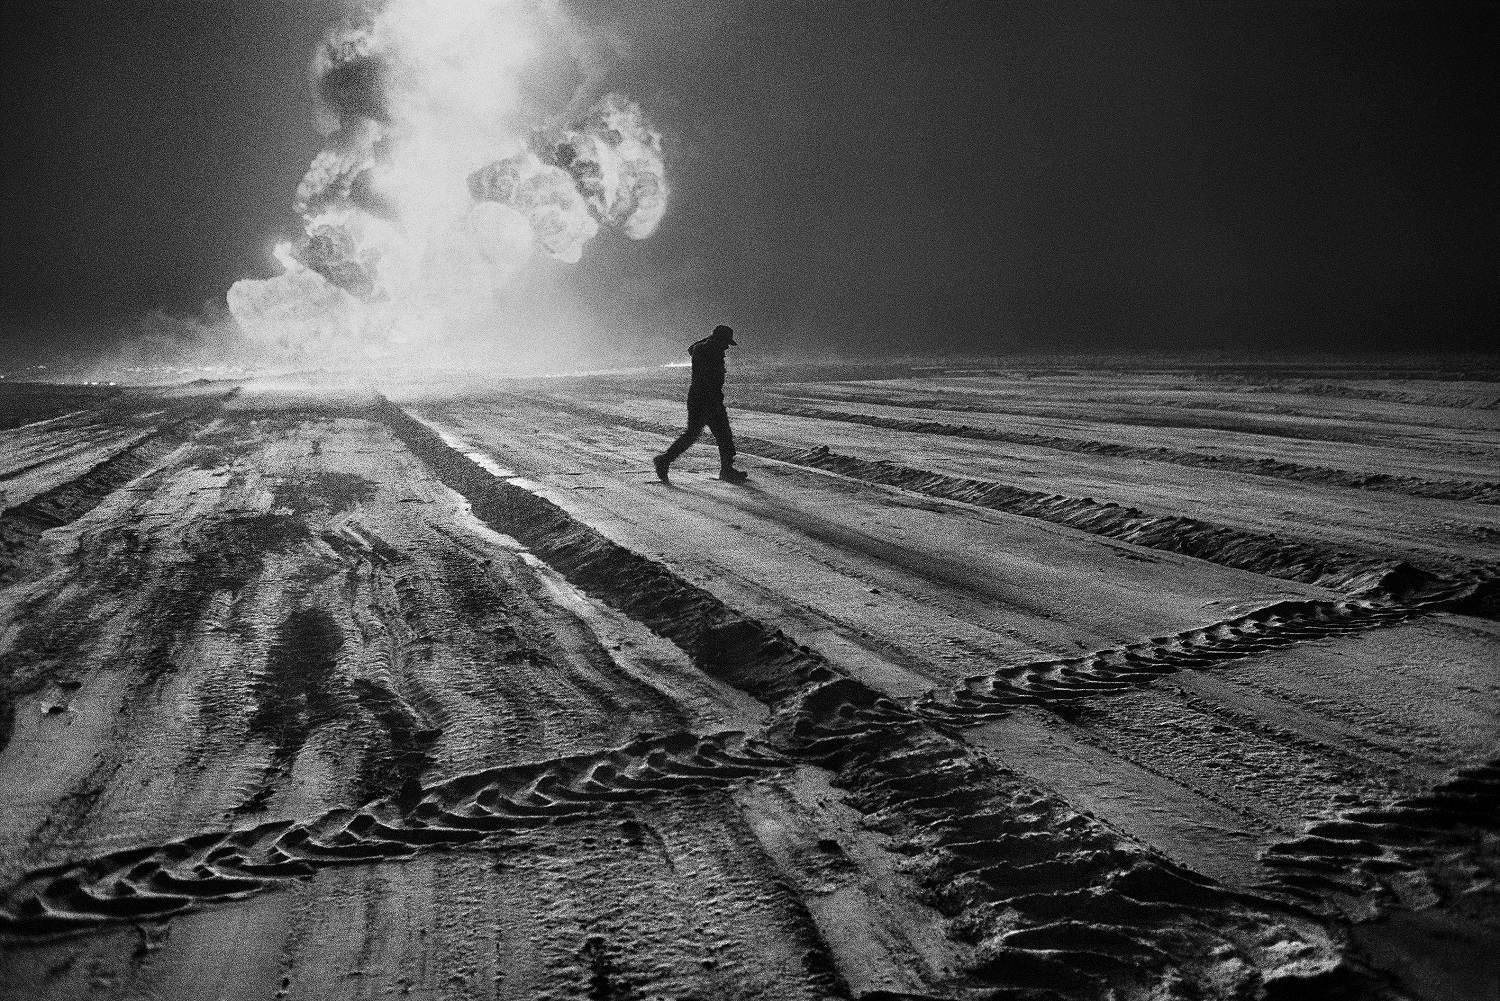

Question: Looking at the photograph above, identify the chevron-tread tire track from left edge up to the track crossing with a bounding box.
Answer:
[0,731,786,939]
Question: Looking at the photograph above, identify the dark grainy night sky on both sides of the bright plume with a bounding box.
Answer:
[0,0,1500,360]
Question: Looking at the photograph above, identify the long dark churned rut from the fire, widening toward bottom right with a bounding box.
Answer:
[369,407,1422,998]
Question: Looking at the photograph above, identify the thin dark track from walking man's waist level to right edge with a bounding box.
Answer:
[740,399,1500,504]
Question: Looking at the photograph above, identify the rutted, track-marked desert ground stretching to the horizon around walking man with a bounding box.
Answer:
[0,356,1500,1001]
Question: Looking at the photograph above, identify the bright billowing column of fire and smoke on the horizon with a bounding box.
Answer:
[228,0,668,360]
